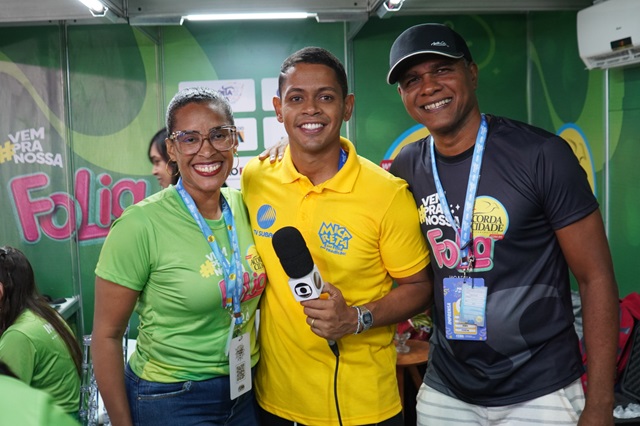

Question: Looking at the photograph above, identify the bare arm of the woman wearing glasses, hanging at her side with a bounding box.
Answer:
[91,277,139,426]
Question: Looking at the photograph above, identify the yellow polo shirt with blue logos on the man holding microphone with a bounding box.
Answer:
[242,138,429,426]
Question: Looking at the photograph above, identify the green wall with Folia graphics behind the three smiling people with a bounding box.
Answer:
[0,12,640,332]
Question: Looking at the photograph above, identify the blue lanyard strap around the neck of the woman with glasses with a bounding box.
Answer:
[176,178,243,326]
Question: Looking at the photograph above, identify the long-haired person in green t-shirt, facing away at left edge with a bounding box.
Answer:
[0,246,82,418]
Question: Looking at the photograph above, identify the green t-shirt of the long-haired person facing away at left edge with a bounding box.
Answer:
[0,310,80,413]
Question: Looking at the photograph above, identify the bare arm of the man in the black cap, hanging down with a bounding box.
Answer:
[556,210,619,425]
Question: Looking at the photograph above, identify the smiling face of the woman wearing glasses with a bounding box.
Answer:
[167,102,237,203]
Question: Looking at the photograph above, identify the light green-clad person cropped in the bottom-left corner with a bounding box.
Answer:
[0,361,79,426]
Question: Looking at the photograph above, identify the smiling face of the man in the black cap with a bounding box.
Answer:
[398,55,480,149]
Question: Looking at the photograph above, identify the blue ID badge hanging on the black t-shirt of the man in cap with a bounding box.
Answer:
[443,277,487,341]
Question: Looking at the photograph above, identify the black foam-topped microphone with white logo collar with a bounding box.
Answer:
[271,226,340,356]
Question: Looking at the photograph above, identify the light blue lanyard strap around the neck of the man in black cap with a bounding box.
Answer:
[429,114,488,272]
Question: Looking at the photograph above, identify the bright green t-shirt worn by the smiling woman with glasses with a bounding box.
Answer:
[96,187,266,383]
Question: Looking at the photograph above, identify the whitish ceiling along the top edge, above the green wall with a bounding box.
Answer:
[0,0,593,25]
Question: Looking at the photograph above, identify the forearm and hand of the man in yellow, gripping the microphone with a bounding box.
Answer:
[301,266,433,340]
